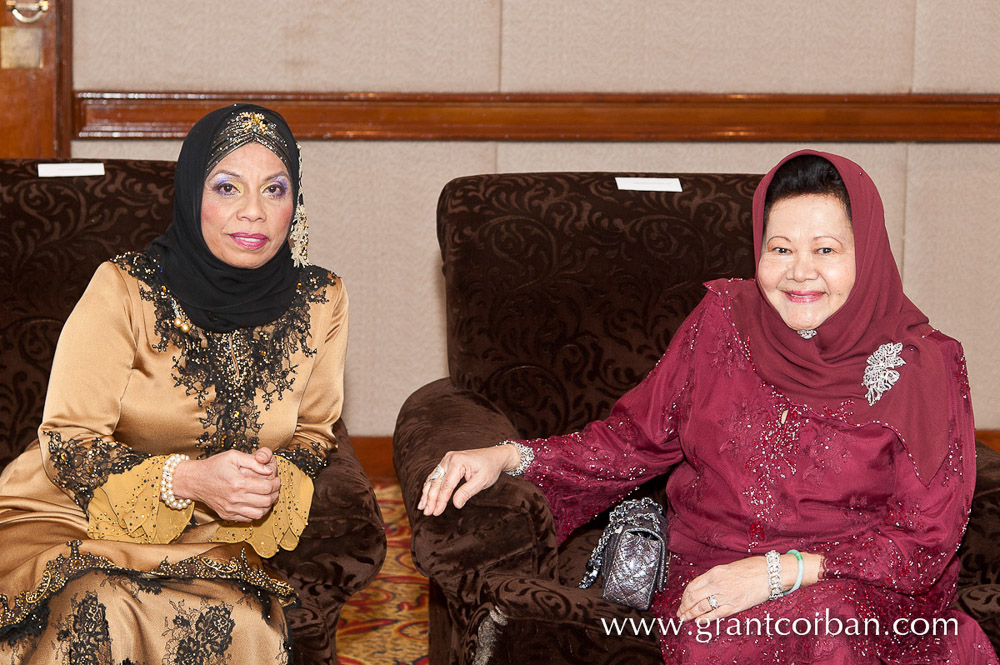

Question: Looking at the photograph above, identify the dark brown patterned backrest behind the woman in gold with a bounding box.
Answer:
[0,159,174,468]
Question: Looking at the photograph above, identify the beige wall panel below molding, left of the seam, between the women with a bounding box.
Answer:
[73,141,496,436]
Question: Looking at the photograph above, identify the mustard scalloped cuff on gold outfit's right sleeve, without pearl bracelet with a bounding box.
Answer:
[212,454,313,557]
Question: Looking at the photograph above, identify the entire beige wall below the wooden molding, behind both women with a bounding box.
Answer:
[73,141,1000,436]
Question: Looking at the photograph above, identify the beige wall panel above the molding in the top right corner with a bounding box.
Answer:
[913,0,1000,93]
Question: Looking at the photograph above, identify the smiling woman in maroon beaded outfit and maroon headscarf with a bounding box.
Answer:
[419,151,998,664]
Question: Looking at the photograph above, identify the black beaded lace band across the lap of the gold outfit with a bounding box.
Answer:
[0,540,296,639]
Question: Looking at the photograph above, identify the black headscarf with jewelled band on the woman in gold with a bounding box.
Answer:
[147,104,301,332]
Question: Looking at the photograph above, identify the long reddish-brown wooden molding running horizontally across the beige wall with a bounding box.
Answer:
[73,91,1000,142]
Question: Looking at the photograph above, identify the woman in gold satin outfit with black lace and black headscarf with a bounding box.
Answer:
[0,104,347,665]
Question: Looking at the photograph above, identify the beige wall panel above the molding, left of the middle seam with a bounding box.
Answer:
[73,0,500,92]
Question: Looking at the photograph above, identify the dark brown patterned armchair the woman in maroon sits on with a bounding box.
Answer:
[393,173,1000,665]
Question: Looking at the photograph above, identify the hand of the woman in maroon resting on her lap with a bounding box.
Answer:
[677,556,770,621]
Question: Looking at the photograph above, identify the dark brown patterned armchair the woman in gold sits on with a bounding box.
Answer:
[0,160,386,665]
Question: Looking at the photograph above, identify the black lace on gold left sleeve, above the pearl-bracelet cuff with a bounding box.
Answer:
[44,431,150,512]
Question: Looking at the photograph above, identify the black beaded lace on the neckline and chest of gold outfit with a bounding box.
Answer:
[112,252,337,475]
